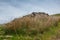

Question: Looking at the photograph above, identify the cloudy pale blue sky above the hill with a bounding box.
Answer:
[0,0,60,24]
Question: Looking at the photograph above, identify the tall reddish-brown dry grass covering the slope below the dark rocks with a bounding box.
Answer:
[5,14,60,34]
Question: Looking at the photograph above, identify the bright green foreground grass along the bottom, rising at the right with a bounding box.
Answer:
[0,23,60,40]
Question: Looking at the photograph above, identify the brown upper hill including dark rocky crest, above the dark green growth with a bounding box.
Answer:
[5,12,60,32]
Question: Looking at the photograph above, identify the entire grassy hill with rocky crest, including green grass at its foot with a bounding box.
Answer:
[0,12,60,40]
